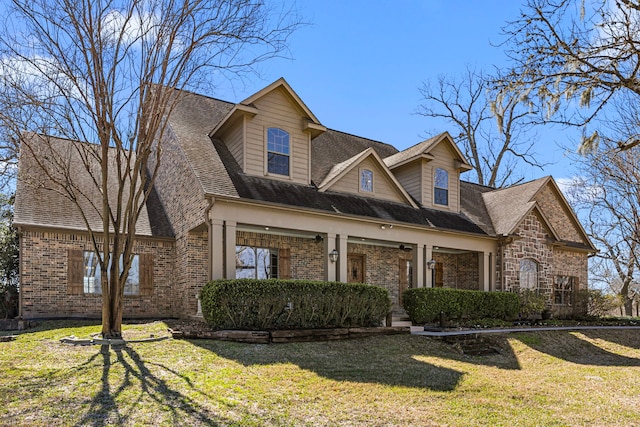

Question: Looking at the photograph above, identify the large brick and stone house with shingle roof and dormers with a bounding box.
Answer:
[15,79,595,318]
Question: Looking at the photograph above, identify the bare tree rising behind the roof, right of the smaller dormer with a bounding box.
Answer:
[418,69,543,188]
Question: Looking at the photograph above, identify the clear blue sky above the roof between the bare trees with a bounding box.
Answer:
[216,0,574,186]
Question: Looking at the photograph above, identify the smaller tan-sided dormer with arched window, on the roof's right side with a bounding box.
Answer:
[384,132,472,212]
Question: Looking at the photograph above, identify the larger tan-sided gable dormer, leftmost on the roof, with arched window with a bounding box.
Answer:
[210,79,326,184]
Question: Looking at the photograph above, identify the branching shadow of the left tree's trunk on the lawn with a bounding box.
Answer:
[75,345,230,427]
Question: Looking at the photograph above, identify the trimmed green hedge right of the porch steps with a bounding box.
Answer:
[402,288,520,324]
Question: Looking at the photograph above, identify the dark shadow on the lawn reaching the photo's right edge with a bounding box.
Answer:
[513,329,640,366]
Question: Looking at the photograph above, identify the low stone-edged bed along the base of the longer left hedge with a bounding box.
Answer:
[167,319,411,344]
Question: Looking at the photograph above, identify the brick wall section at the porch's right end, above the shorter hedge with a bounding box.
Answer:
[433,252,480,291]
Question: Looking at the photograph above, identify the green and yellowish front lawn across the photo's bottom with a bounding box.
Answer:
[0,322,640,426]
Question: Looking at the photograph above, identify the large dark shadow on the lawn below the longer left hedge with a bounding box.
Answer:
[196,336,476,391]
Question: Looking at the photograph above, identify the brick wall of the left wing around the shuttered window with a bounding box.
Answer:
[20,229,175,318]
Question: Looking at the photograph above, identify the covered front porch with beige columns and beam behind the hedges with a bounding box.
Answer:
[204,201,496,307]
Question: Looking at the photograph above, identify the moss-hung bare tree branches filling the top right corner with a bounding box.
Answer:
[503,0,640,150]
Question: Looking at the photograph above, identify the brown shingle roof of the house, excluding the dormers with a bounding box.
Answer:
[15,85,592,246]
